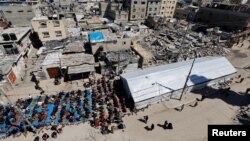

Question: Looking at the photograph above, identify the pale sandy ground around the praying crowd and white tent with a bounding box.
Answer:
[2,39,250,141]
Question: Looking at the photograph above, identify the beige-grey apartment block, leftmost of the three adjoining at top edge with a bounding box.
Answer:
[129,0,147,22]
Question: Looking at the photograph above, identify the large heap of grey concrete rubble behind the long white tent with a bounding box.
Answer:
[141,22,229,64]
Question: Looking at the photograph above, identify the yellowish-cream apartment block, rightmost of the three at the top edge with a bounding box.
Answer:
[160,0,177,18]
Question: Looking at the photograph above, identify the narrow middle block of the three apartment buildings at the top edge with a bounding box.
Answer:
[146,0,161,16]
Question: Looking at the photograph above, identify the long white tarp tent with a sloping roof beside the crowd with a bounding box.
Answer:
[121,57,237,108]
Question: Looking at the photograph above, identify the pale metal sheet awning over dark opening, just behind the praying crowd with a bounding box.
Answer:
[68,64,95,74]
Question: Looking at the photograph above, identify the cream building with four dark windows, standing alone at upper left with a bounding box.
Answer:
[31,16,67,42]
